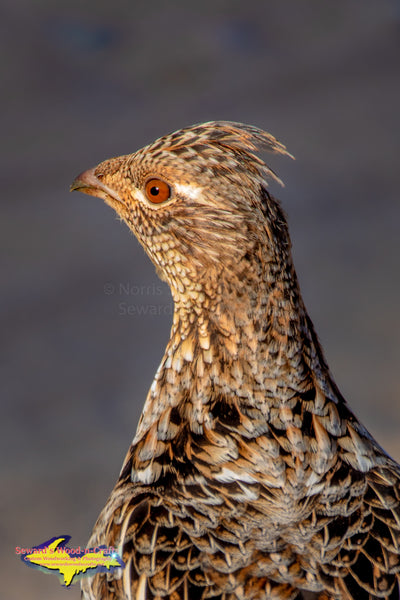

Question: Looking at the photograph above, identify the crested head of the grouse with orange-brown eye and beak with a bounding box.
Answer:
[71,121,290,310]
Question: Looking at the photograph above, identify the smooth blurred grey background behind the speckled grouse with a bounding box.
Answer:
[0,0,400,600]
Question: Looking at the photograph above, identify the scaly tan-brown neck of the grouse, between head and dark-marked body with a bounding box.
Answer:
[133,257,331,445]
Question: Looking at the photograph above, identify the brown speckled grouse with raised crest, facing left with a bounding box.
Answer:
[71,121,400,600]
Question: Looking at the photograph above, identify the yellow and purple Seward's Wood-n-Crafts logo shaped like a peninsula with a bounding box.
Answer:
[15,535,125,587]
